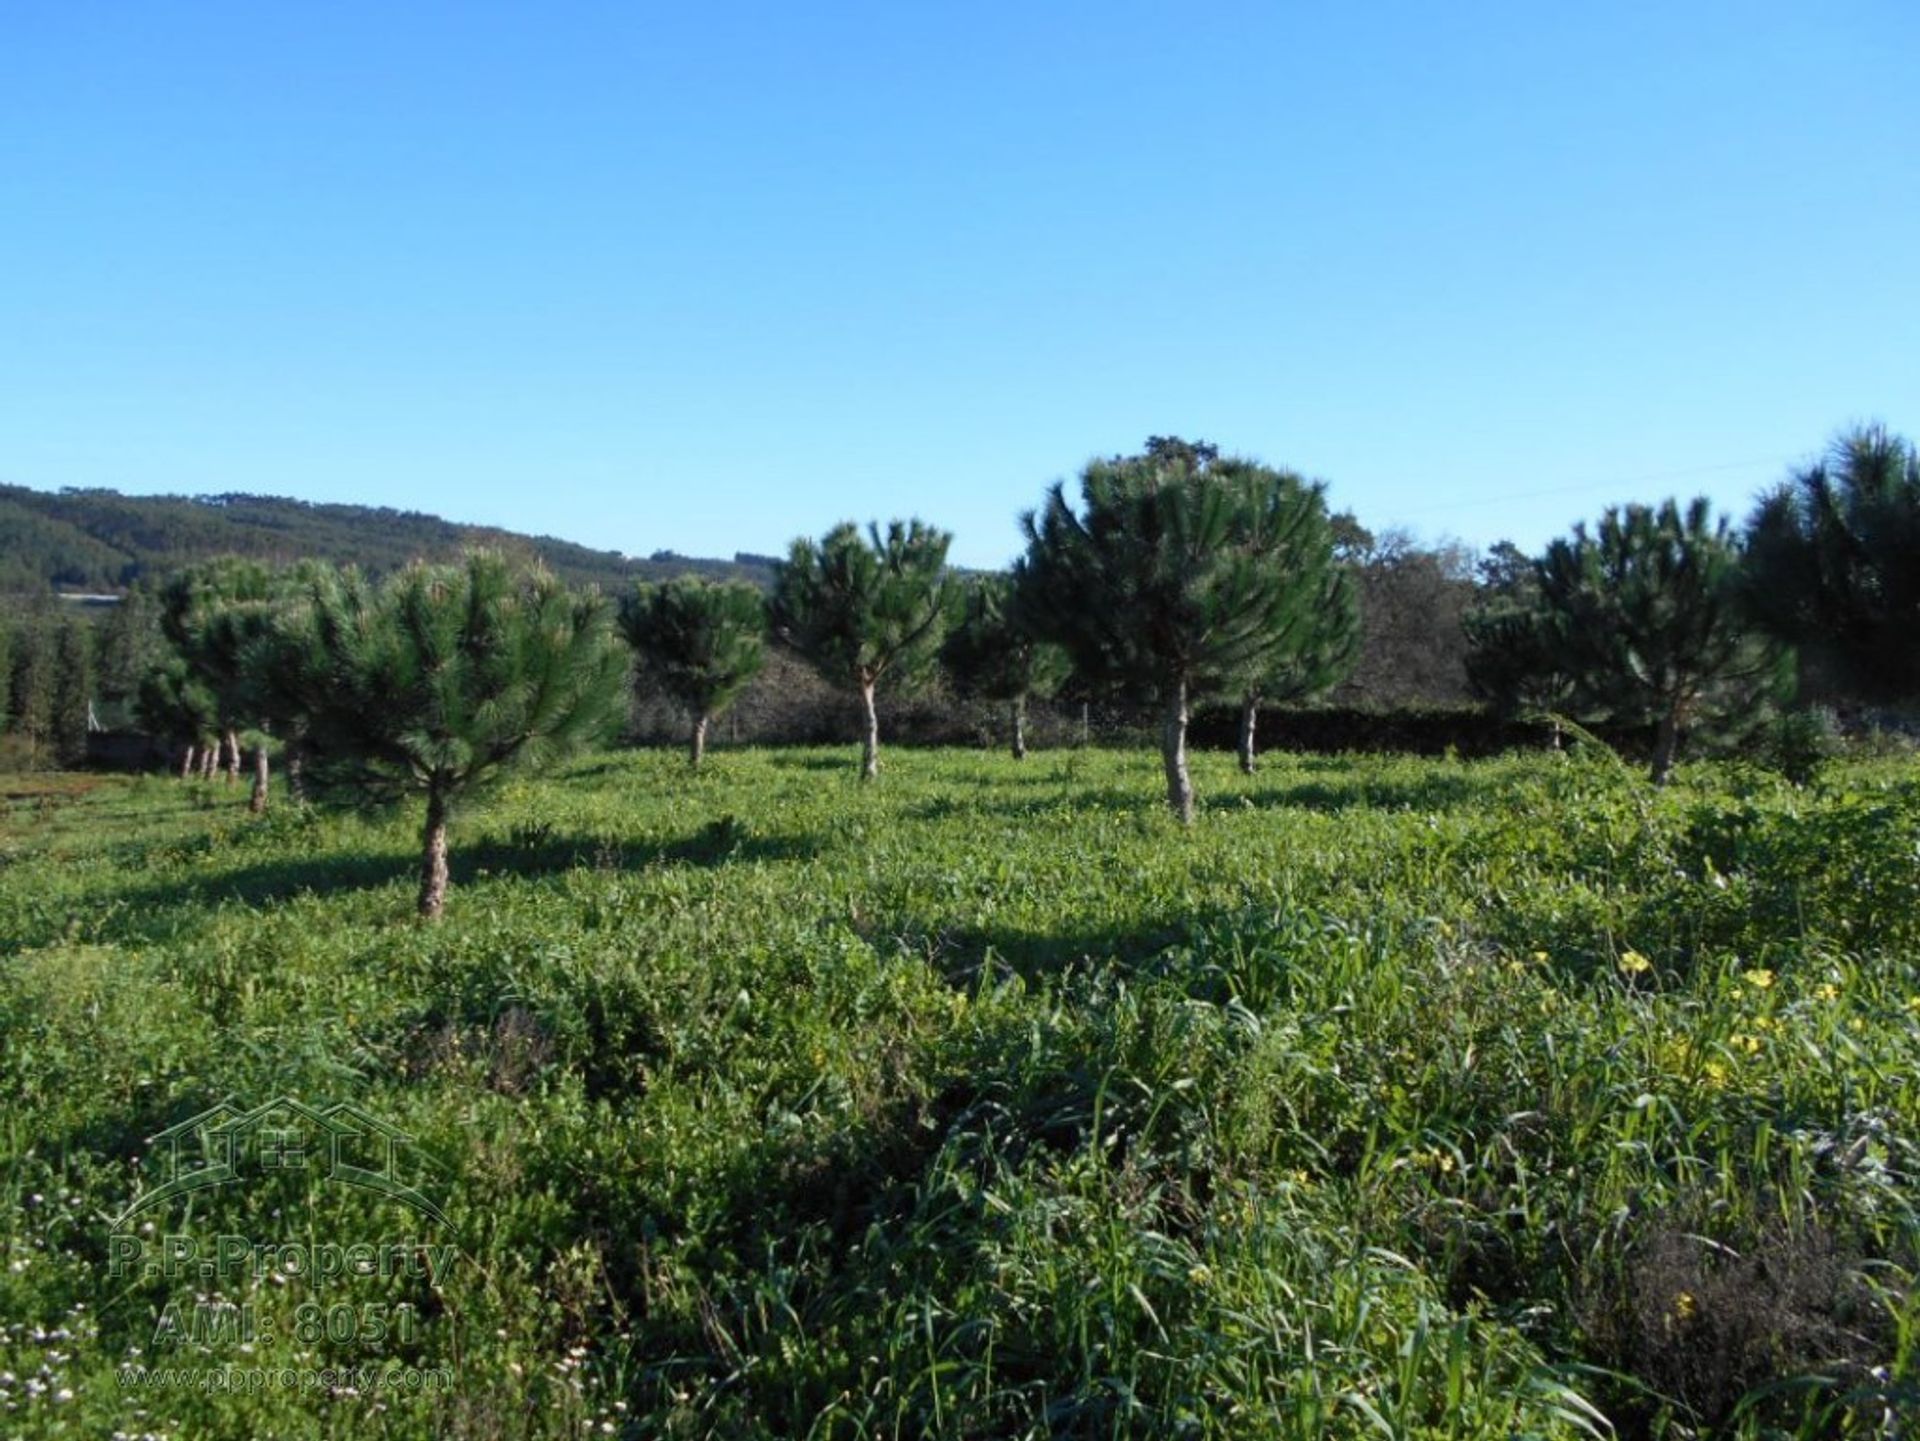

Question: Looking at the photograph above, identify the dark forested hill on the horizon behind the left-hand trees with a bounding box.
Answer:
[0,485,772,591]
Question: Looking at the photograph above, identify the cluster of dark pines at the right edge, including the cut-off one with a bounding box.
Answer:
[1465,426,1920,785]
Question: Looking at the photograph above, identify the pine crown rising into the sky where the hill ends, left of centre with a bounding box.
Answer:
[774,520,952,691]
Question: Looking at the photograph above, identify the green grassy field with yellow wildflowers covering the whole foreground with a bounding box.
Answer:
[0,750,1920,1437]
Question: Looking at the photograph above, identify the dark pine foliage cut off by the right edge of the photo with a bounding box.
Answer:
[1747,426,1920,700]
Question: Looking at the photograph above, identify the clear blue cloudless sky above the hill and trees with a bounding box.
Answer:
[0,0,1920,564]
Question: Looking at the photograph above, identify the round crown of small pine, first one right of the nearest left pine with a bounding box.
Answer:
[620,578,766,718]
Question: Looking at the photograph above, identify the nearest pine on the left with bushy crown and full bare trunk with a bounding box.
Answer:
[305,551,626,919]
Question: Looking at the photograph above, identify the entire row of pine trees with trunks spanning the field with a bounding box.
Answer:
[60,430,1920,915]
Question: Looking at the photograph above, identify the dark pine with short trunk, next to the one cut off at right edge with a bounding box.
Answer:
[1538,499,1791,781]
